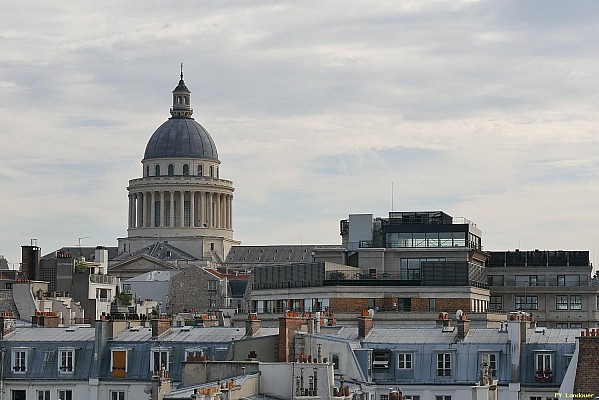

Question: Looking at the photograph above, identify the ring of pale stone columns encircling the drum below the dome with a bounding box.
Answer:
[129,190,233,229]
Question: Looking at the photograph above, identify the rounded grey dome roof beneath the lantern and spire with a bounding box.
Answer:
[144,117,218,161]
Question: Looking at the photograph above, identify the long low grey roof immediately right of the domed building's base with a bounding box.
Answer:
[225,245,319,264]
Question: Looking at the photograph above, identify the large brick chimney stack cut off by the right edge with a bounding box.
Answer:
[572,328,599,393]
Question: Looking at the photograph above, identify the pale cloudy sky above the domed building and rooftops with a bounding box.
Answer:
[0,0,599,263]
